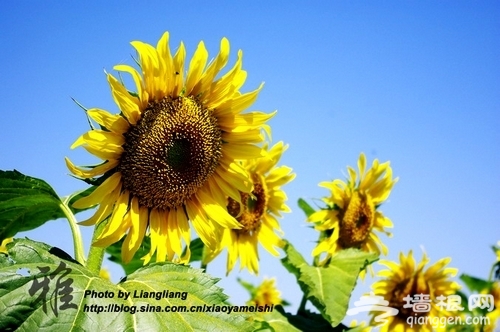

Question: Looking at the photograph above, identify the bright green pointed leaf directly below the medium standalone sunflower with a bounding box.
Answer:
[281,242,377,327]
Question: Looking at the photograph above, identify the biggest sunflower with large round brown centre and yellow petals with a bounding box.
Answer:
[66,33,274,262]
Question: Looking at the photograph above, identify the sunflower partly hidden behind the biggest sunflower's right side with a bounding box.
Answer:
[206,142,295,274]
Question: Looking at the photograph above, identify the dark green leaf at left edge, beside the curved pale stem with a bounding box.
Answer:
[0,170,64,242]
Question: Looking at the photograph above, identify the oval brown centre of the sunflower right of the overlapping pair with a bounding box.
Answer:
[339,191,375,248]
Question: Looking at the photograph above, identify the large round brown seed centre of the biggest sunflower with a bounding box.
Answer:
[118,97,222,209]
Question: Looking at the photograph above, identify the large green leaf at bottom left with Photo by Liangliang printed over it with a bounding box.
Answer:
[0,239,252,332]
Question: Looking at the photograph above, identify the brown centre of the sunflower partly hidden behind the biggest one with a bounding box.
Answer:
[227,174,267,235]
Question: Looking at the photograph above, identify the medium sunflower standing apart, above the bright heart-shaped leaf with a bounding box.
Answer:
[308,153,398,263]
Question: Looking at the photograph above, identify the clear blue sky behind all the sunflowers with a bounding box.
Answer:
[0,1,500,326]
